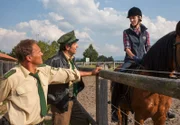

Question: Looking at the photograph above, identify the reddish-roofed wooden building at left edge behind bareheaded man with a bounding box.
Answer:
[0,53,17,77]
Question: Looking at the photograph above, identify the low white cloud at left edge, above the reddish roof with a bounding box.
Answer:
[0,28,27,52]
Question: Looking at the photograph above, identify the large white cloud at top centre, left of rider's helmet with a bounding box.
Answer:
[42,0,128,34]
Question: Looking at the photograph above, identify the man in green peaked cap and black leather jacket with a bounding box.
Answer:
[46,31,99,125]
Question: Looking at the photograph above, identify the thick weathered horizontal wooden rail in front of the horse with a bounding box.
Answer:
[99,70,180,99]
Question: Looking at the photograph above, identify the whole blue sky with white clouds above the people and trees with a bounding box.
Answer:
[0,0,180,59]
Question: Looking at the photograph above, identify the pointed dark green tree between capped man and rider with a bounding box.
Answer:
[83,44,98,62]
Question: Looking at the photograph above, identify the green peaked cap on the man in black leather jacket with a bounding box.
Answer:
[57,30,79,44]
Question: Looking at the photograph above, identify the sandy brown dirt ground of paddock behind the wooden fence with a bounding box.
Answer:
[78,77,180,125]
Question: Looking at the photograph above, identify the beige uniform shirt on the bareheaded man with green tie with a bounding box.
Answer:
[0,65,80,125]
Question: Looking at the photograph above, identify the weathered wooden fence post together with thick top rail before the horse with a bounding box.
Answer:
[96,70,180,125]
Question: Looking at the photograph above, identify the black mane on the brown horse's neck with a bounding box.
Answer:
[142,32,176,71]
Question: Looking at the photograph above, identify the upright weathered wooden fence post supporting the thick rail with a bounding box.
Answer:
[96,76,108,125]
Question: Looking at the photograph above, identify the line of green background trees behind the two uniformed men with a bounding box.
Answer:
[0,40,114,62]
